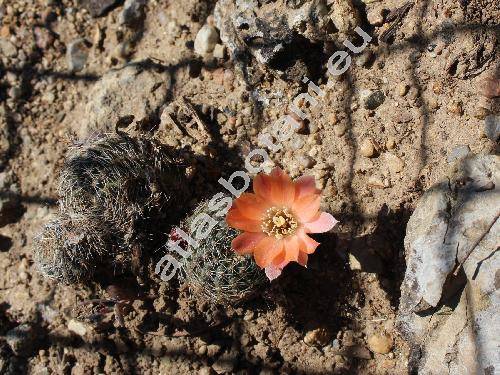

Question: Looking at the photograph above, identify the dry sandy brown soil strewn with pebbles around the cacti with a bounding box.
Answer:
[0,0,500,374]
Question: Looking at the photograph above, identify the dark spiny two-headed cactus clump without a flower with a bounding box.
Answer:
[35,135,187,283]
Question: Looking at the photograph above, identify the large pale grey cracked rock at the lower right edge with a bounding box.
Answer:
[398,155,500,374]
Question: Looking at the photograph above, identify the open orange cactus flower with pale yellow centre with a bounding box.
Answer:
[226,168,338,280]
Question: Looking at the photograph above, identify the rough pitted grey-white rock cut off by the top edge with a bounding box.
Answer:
[214,0,359,65]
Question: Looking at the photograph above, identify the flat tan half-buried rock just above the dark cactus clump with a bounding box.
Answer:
[74,60,170,138]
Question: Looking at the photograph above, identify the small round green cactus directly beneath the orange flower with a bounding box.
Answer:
[182,201,266,305]
